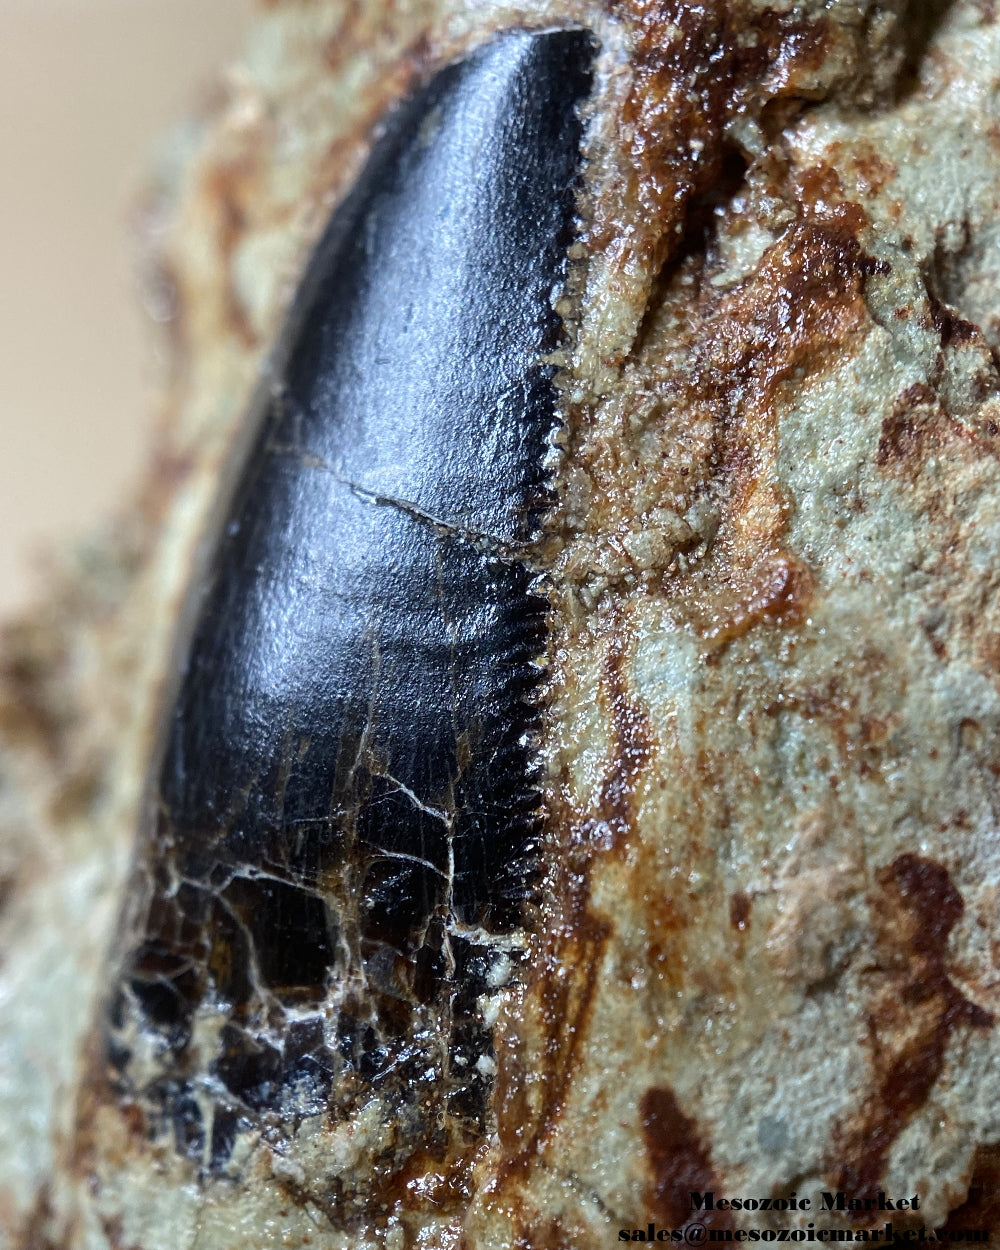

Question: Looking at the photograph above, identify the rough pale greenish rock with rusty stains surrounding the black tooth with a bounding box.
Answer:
[0,0,1000,1250]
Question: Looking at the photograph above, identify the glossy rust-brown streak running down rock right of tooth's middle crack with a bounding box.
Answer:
[650,218,878,650]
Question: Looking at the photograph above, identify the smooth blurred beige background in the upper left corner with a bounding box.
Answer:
[0,0,251,615]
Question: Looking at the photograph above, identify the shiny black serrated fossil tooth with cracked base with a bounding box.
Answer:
[111,30,593,1166]
